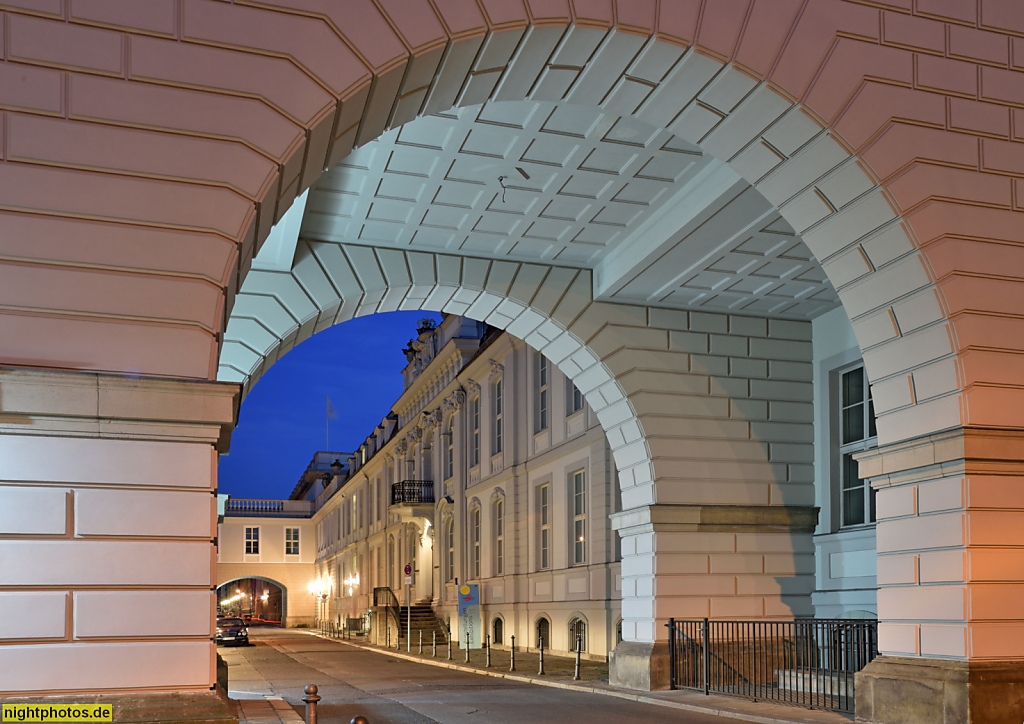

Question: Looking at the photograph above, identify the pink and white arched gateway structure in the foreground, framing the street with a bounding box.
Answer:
[0,0,1024,724]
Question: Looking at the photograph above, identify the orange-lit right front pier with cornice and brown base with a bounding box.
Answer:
[856,427,1024,724]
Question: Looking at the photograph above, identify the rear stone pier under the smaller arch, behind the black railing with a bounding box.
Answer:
[609,505,818,690]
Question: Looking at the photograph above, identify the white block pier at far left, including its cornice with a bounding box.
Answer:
[0,368,239,720]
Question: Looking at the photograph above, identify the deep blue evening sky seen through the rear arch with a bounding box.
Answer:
[217,311,440,499]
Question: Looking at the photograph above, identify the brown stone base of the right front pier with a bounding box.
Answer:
[856,656,1024,724]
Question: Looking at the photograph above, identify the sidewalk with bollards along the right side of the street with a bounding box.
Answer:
[307,631,853,724]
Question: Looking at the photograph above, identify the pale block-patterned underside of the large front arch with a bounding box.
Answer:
[214,25,961,452]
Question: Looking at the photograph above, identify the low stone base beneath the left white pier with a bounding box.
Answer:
[0,691,239,724]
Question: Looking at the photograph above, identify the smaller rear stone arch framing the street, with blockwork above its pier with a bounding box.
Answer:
[225,240,813,508]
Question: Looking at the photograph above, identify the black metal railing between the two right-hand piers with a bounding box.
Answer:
[668,619,879,713]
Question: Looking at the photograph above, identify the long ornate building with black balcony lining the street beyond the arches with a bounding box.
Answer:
[303,314,622,657]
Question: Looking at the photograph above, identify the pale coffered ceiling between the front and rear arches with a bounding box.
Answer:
[282,101,839,318]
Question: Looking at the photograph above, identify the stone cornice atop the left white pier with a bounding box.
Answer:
[0,368,242,453]
